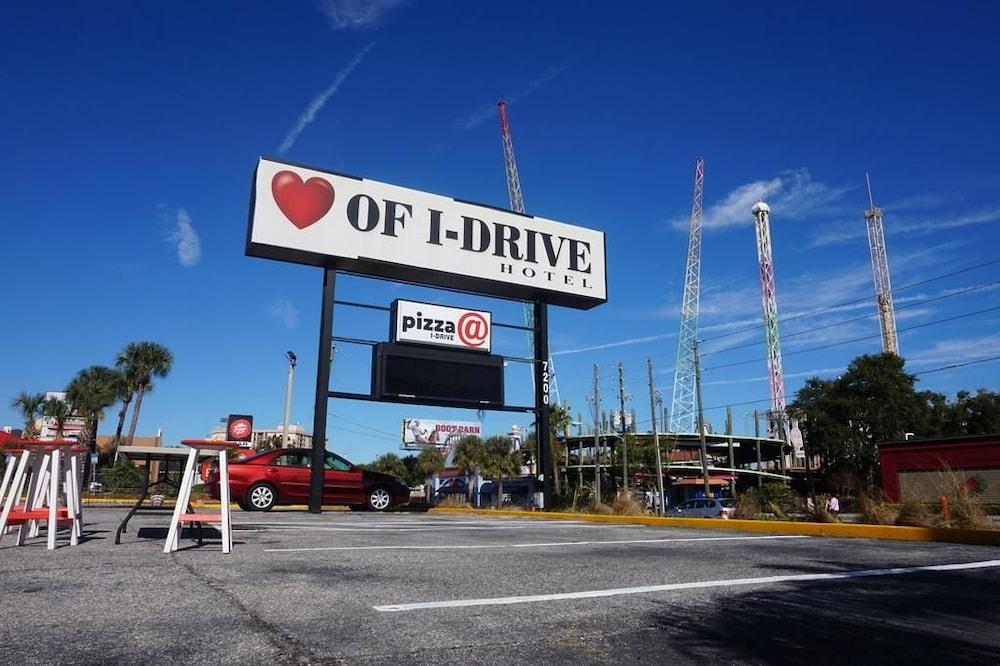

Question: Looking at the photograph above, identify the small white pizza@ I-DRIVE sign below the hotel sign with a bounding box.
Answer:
[392,299,493,352]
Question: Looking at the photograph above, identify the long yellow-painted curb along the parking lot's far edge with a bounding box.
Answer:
[431,508,1000,546]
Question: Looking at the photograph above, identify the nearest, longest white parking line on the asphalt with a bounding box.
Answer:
[373,560,1000,613]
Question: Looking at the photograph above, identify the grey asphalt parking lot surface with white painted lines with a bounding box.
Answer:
[0,509,1000,664]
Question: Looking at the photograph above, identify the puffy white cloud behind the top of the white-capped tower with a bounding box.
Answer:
[669,168,857,231]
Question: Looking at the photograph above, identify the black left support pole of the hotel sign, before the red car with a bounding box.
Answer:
[309,268,337,513]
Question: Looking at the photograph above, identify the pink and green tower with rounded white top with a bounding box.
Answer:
[751,201,785,439]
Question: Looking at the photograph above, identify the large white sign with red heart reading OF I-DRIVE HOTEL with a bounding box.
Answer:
[246,158,607,309]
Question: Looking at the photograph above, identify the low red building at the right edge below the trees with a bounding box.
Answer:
[878,435,1000,504]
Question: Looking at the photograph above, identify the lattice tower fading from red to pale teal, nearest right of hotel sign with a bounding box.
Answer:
[668,157,705,432]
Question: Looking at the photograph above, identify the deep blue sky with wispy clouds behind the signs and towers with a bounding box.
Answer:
[0,0,1000,461]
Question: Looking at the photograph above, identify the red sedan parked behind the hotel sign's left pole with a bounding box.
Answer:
[205,449,410,511]
